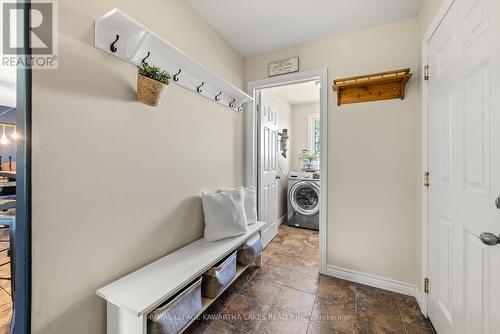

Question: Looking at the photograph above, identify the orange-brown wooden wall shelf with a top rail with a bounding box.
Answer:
[333,68,412,106]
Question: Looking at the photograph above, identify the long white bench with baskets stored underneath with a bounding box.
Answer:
[97,222,265,334]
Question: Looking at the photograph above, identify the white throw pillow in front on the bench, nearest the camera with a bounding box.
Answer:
[201,188,248,241]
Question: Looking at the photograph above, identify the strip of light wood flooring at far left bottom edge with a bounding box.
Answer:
[0,231,12,334]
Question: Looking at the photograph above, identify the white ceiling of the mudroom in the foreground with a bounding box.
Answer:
[189,0,422,57]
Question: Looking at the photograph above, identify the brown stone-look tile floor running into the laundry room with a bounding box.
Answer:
[187,226,433,334]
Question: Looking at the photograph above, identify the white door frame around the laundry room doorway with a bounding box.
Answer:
[245,68,328,274]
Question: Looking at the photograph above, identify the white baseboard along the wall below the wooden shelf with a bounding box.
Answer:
[327,266,417,297]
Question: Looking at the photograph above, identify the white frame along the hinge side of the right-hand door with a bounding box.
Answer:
[422,0,455,316]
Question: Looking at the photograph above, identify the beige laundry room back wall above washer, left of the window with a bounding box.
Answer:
[290,103,319,171]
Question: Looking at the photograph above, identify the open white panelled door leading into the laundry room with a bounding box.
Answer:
[257,92,278,247]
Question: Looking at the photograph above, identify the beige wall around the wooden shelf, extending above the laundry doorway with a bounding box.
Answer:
[245,18,418,283]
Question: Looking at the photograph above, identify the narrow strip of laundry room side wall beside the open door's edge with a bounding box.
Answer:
[263,89,293,219]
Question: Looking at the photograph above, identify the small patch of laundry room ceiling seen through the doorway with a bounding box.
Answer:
[264,81,319,105]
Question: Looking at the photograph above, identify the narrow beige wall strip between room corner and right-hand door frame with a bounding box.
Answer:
[416,0,444,291]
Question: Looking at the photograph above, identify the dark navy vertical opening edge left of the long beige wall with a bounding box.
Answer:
[9,0,32,334]
